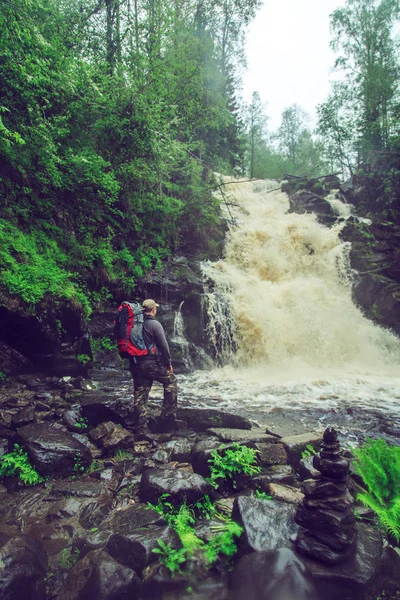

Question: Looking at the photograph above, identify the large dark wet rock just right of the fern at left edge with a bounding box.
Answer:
[18,423,92,477]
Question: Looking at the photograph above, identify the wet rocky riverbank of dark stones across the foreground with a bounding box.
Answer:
[0,371,400,600]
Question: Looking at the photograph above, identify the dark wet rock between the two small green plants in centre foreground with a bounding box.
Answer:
[140,468,213,506]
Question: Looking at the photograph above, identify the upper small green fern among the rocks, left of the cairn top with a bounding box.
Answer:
[208,443,261,487]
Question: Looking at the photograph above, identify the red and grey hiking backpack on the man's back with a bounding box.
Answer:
[114,302,148,358]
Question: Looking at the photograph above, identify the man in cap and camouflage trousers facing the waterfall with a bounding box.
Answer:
[130,299,178,436]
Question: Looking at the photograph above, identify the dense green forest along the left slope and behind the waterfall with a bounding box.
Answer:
[0,0,400,317]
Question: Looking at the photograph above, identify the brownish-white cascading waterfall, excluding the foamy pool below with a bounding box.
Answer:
[204,178,400,374]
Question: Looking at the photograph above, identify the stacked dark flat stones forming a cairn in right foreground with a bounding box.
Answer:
[295,427,356,565]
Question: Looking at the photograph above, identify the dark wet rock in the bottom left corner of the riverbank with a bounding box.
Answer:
[0,534,47,600]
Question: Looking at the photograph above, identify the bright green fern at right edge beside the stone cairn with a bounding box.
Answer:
[353,439,400,542]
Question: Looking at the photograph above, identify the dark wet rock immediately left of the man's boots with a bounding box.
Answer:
[81,390,135,429]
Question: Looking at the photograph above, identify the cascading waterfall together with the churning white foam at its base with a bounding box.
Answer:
[174,179,400,422]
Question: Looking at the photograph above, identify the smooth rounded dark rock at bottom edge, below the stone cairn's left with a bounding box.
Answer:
[229,548,325,600]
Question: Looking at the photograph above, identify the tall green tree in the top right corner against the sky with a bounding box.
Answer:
[331,0,400,159]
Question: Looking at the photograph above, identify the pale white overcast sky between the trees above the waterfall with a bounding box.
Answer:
[243,0,345,131]
